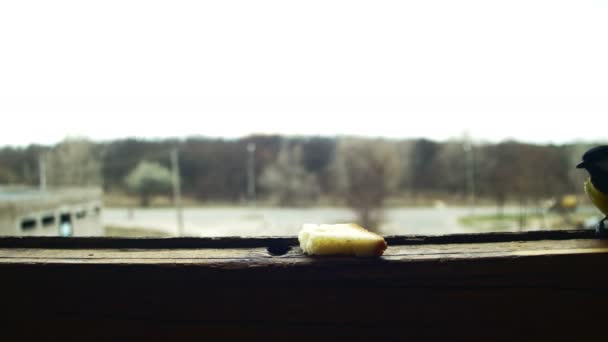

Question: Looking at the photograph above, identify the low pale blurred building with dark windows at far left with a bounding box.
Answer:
[0,187,103,236]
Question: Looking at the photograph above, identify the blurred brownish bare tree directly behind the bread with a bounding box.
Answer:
[332,138,402,229]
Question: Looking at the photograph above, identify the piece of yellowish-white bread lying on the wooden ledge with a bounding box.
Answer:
[298,223,386,257]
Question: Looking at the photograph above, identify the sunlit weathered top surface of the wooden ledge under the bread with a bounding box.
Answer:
[0,239,608,265]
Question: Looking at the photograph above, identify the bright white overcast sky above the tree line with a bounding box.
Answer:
[0,0,608,145]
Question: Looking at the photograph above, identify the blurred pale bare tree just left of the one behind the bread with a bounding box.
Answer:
[260,143,320,206]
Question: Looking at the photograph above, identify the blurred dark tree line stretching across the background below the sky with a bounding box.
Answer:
[0,135,589,226]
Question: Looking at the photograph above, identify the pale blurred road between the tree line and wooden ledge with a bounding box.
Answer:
[103,207,520,237]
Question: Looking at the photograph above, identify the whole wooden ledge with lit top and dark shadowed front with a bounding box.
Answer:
[0,239,608,341]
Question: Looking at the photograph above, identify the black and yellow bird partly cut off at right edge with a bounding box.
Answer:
[576,145,608,238]
